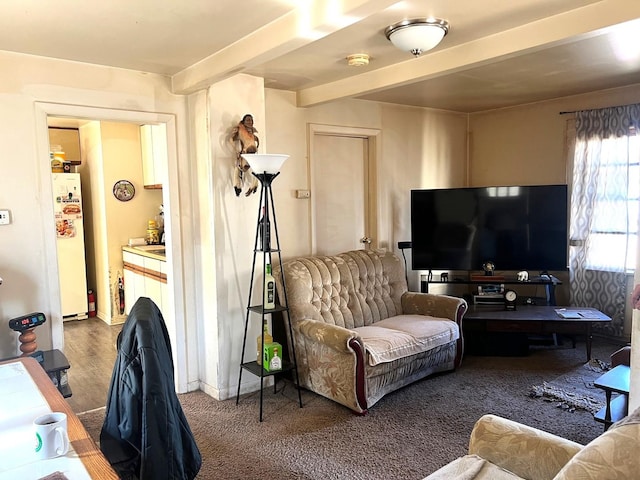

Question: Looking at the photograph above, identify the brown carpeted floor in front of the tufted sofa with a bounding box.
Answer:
[79,341,619,480]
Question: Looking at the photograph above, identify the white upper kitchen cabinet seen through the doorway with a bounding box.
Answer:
[140,124,168,188]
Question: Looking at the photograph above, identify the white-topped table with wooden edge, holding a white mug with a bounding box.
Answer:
[0,357,118,480]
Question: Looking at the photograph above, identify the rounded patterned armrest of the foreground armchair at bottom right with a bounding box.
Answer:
[469,415,583,480]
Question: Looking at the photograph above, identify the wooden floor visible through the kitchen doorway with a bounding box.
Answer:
[64,318,122,413]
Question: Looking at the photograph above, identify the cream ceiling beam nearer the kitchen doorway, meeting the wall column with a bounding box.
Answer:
[171,0,398,94]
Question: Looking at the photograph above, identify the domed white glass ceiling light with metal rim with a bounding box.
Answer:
[384,18,449,57]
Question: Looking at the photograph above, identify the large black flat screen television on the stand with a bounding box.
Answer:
[411,185,568,271]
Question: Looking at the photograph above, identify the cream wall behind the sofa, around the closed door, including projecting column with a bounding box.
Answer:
[190,84,466,399]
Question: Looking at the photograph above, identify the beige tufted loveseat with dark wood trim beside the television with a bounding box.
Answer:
[273,250,467,413]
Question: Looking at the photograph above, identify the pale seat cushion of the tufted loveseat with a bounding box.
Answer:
[353,315,460,366]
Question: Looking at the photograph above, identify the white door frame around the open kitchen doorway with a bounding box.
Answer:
[34,101,188,391]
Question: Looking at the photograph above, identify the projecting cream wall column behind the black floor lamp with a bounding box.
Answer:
[190,75,271,398]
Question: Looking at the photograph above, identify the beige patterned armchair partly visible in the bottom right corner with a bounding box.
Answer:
[424,410,640,480]
